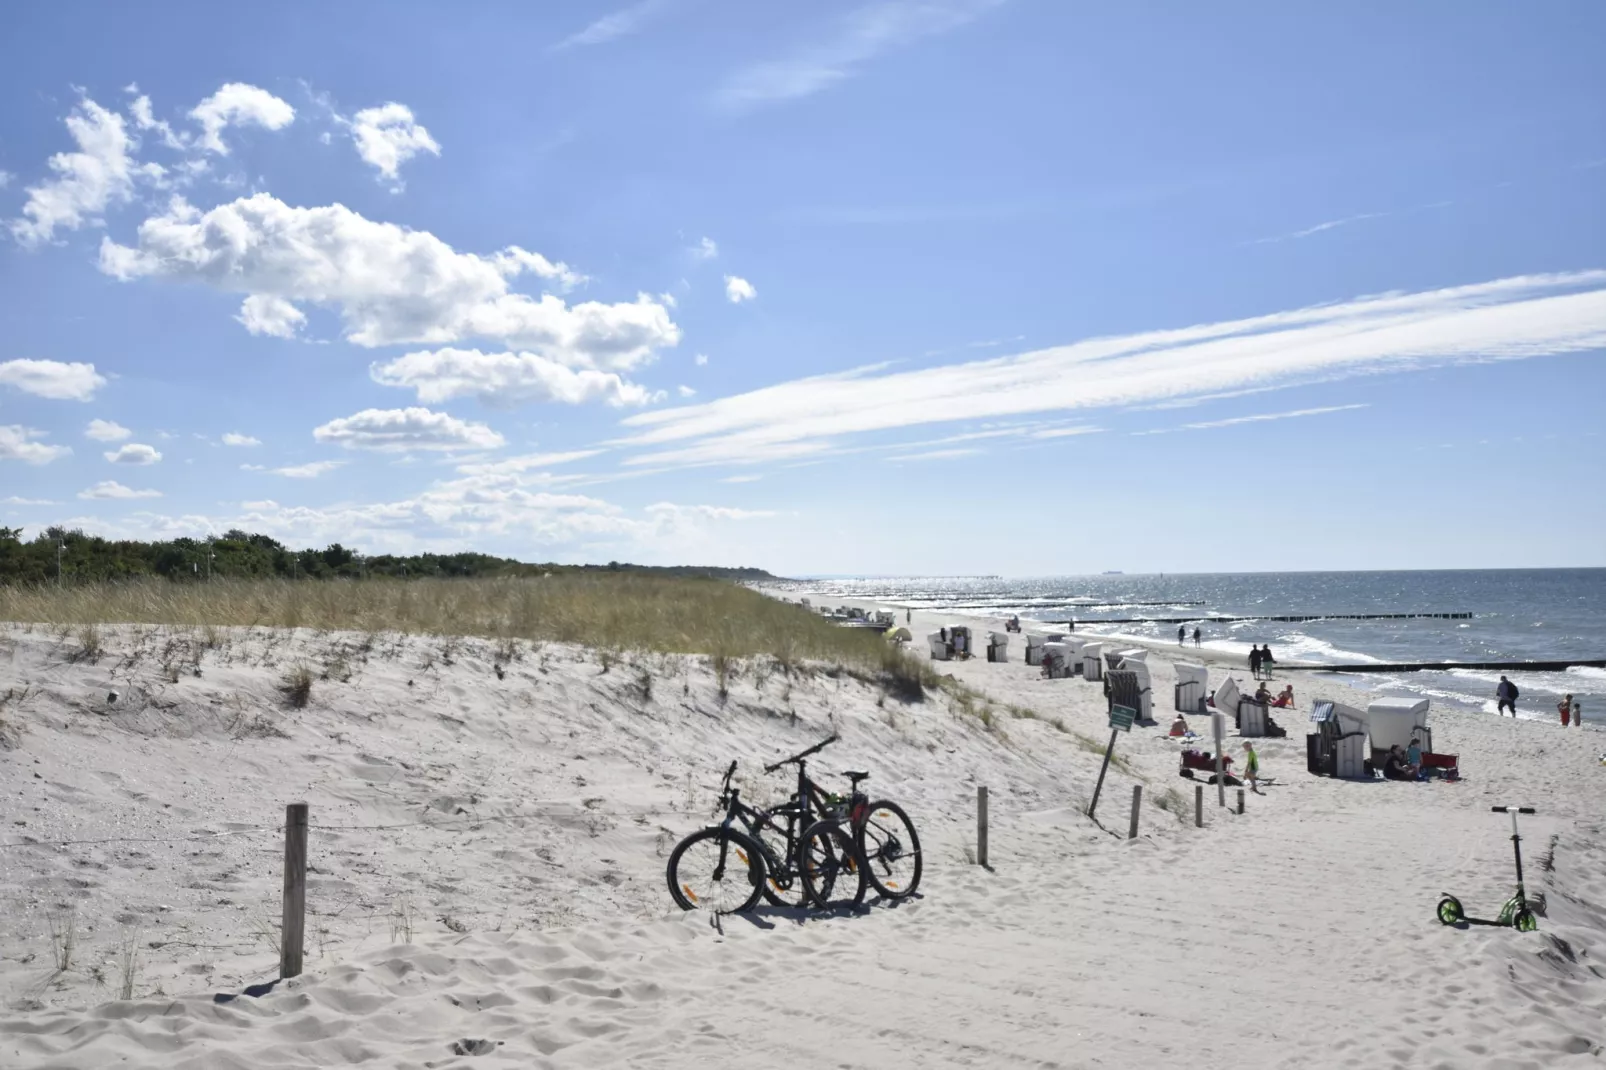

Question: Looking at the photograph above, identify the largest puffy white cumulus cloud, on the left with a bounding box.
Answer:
[100,193,681,371]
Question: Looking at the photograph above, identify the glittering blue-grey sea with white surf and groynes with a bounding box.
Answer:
[790,569,1606,723]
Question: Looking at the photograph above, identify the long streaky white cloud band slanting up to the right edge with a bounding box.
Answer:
[623,272,1606,464]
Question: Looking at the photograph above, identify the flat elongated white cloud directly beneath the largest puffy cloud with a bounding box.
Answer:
[369,349,652,406]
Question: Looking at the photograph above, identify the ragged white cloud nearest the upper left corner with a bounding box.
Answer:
[11,98,162,246]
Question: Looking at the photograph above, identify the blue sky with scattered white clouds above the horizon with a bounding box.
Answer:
[0,0,1606,575]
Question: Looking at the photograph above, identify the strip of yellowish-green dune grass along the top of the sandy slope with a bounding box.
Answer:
[0,572,936,699]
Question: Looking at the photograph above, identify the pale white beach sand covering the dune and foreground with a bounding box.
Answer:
[0,614,1606,1068]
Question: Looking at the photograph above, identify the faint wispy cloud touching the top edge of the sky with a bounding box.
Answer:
[715,0,1002,111]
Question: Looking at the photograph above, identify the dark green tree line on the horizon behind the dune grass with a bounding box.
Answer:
[0,527,774,585]
